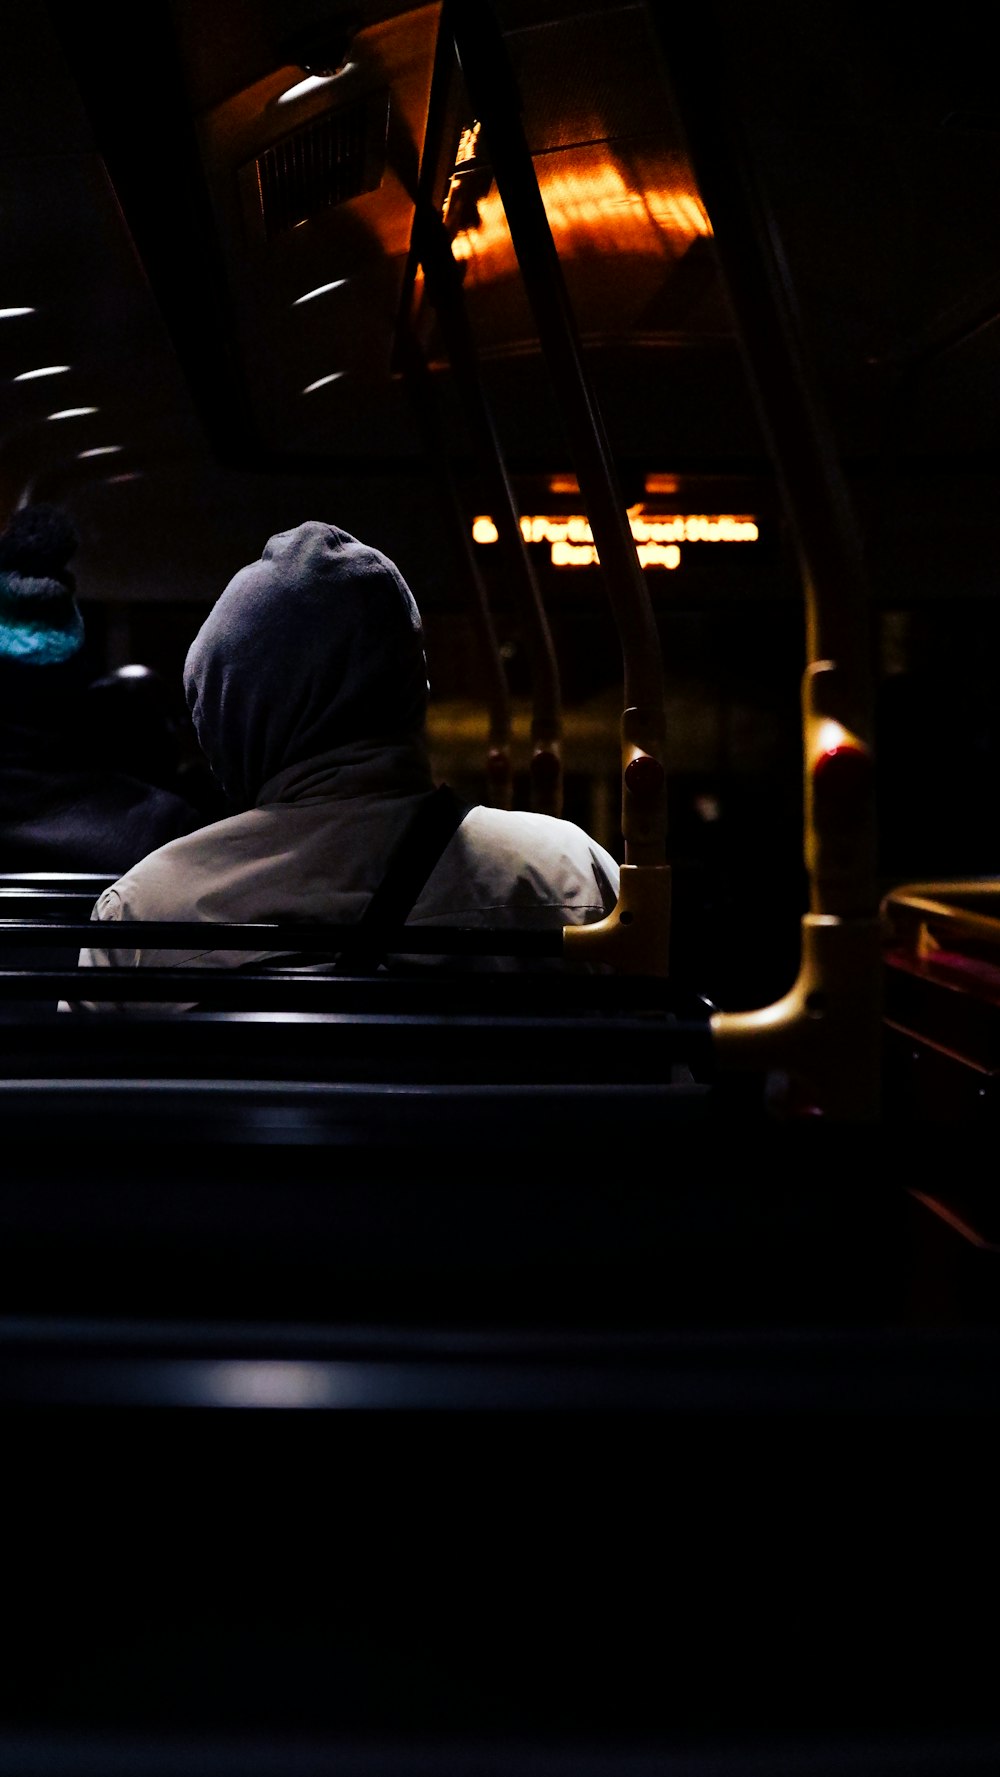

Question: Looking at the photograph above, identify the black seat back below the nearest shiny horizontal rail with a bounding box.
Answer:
[0,1402,1000,1755]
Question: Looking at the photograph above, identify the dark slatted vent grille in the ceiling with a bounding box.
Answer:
[242,92,389,240]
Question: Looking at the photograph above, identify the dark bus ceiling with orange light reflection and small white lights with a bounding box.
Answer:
[0,0,1000,599]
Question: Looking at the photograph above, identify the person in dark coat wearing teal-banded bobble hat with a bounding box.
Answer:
[0,501,202,876]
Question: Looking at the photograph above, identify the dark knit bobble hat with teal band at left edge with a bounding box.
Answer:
[0,505,83,666]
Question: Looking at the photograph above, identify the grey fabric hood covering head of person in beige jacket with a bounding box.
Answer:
[185,519,428,807]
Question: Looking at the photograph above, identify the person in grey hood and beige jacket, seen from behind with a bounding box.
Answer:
[80,521,618,1009]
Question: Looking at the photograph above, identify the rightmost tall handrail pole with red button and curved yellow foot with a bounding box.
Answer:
[650,0,881,1121]
